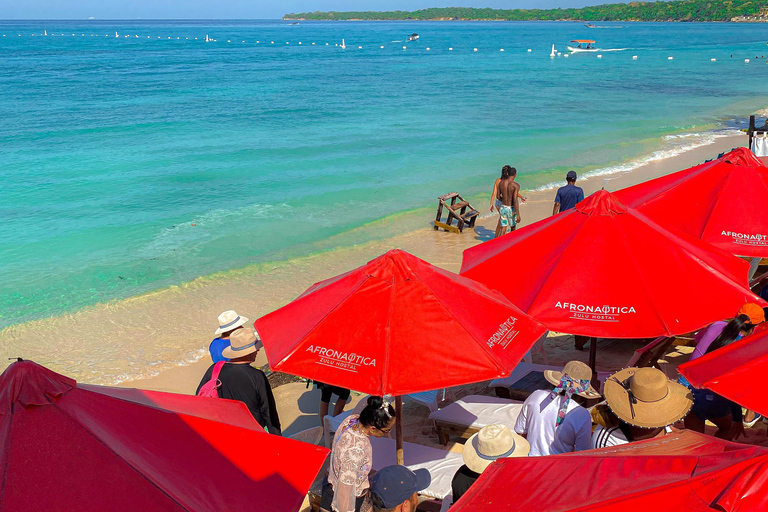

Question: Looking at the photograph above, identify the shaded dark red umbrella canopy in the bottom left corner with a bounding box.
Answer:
[0,361,328,512]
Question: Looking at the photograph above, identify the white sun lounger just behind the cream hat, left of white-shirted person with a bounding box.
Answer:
[429,395,523,445]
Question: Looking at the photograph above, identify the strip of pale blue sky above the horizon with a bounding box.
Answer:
[0,0,608,19]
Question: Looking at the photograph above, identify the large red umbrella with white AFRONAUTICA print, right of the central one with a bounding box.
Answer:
[461,190,763,338]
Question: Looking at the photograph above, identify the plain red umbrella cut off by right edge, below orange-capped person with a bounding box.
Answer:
[678,331,768,416]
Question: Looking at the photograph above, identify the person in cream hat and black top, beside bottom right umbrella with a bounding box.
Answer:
[451,425,531,503]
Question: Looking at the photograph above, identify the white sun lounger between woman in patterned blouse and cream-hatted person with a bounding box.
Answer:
[370,437,464,500]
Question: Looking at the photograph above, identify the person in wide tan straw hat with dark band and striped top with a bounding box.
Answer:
[592,368,693,448]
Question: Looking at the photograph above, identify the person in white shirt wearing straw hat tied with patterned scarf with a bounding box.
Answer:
[515,361,600,456]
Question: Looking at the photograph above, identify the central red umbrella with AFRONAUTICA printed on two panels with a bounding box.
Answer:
[254,250,546,395]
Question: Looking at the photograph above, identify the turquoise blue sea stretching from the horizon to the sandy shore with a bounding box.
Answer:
[0,21,768,327]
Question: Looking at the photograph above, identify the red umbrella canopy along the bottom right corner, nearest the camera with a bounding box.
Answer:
[451,431,768,512]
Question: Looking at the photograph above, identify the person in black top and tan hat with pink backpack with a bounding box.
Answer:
[197,329,282,436]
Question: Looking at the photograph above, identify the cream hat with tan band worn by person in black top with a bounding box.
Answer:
[463,425,531,473]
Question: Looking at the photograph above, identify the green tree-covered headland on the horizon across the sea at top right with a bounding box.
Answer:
[283,0,768,21]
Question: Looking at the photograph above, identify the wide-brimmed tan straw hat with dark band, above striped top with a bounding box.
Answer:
[603,368,693,428]
